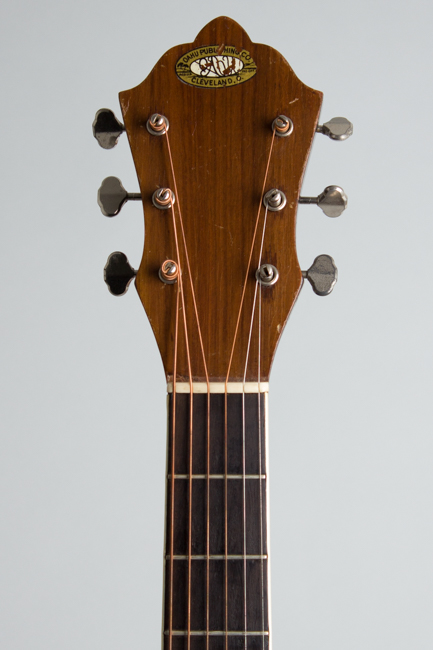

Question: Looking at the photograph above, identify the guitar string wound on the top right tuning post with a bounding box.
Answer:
[224,130,275,650]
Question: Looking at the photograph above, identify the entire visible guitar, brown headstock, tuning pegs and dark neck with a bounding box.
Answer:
[93,17,352,650]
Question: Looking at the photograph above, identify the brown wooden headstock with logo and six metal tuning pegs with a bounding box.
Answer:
[93,17,352,381]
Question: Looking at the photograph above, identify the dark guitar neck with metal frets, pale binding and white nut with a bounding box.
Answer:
[164,383,269,650]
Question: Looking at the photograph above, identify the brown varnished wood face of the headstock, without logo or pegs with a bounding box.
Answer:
[120,17,322,381]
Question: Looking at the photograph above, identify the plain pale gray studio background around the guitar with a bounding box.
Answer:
[0,0,433,650]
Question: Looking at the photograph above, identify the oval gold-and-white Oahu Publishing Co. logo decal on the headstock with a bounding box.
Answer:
[176,45,257,88]
